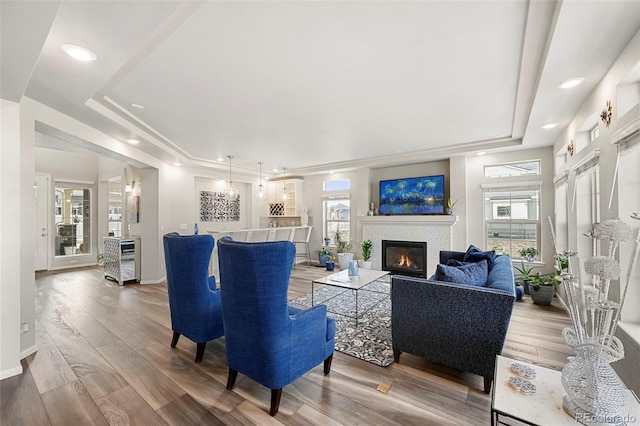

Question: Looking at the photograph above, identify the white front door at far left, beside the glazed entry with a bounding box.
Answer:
[33,173,51,271]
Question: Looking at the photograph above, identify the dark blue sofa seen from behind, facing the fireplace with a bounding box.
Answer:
[391,251,516,393]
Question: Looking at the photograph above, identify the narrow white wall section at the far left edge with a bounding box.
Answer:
[0,99,23,380]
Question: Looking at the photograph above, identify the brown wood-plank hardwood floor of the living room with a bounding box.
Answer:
[0,265,572,426]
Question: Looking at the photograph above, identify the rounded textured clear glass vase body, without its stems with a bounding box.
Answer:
[562,329,627,424]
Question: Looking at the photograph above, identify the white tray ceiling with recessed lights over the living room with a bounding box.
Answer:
[0,0,640,174]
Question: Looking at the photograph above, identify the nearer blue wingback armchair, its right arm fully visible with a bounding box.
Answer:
[218,237,336,416]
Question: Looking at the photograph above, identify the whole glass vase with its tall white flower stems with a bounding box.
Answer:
[562,218,640,423]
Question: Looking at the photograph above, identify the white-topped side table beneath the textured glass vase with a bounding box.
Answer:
[491,355,640,426]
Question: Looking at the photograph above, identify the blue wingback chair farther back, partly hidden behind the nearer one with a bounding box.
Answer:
[163,232,224,362]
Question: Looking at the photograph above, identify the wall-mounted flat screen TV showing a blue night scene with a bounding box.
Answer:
[379,175,445,215]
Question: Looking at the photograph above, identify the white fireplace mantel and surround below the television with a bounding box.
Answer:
[358,215,458,275]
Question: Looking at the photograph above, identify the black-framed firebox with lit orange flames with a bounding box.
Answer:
[382,240,427,278]
